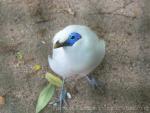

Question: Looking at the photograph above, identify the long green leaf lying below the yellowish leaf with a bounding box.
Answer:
[36,84,55,113]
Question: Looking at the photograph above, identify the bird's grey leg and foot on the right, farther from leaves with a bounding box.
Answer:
[86,75,105,91]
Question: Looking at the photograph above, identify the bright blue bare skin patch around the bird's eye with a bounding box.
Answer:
[65,32,81,46]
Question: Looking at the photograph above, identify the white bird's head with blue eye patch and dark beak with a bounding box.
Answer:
[53,25,92,49]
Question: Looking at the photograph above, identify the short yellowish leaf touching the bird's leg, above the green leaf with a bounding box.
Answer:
[45,73,62,87]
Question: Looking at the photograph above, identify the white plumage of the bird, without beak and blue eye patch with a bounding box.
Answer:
[48,25,105,79]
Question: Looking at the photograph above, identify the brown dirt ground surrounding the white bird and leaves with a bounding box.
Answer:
[0,0,150,113]
